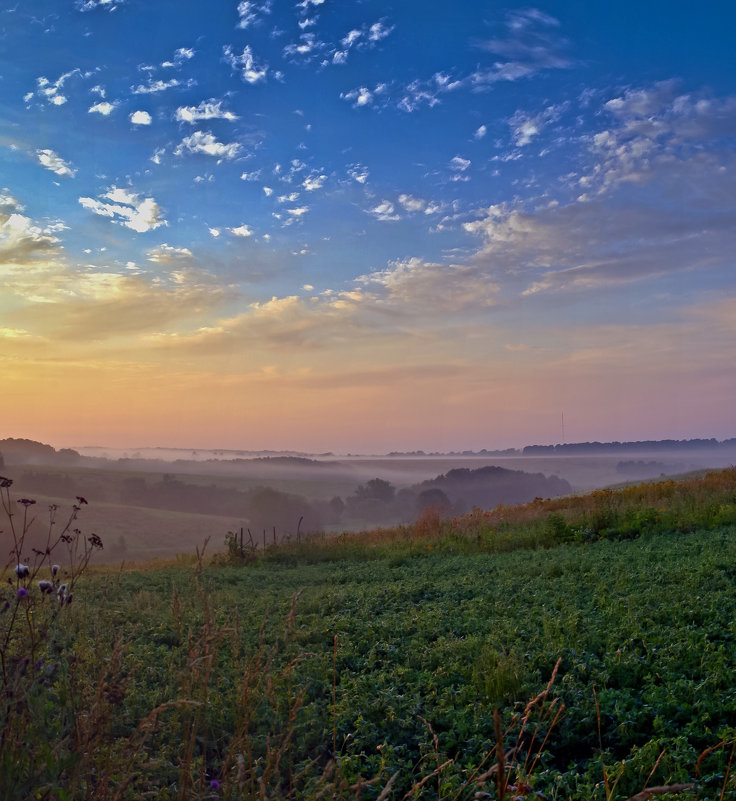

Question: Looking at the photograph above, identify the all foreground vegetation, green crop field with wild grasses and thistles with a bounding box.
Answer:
[0,469,736,801]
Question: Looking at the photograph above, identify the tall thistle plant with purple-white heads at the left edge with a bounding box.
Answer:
[0,476,102,798]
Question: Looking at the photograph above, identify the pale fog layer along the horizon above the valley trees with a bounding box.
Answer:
[5,439,736,488]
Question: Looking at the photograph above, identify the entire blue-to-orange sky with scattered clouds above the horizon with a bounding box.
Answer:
[0,0,736,453]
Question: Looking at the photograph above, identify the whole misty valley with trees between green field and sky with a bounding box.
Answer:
[0,439,736,562]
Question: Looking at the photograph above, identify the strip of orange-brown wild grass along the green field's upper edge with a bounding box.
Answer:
[216,467,736,564]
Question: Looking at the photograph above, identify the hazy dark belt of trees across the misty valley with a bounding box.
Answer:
[4,467,572,538]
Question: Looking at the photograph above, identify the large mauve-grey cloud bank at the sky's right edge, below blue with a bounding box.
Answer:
[463,125,736,296]
